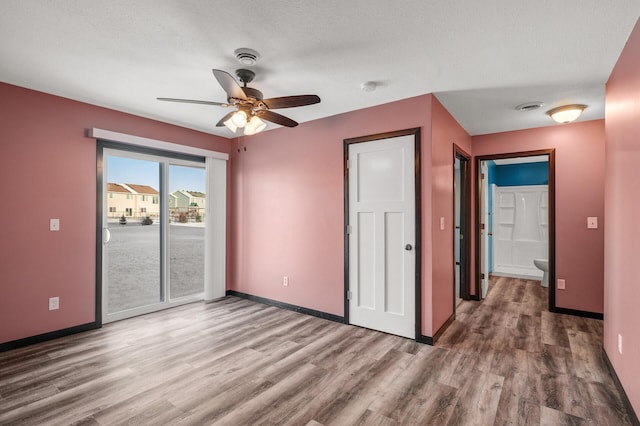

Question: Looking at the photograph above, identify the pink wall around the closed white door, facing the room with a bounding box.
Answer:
[230,95,453,333]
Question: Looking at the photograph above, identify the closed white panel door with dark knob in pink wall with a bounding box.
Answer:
[348,135,416,338]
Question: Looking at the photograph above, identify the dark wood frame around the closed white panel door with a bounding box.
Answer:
[343,127,422,341]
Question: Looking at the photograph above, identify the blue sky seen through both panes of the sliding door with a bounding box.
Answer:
[107,156,206,192]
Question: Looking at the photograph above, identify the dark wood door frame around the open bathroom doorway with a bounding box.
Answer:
[474,148,556,312]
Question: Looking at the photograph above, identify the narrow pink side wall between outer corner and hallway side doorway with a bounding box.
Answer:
[423,97,471,336]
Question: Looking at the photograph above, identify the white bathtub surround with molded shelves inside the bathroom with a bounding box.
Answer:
[493,185,549,280]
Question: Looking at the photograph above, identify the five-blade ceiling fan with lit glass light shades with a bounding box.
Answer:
[157,68,320,135]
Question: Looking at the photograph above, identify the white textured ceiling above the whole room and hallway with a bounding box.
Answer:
[0,0,640,137]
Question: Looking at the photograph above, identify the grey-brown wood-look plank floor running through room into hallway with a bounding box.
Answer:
[0,278,631,425]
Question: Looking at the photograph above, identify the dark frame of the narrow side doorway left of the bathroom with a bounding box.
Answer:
[453,143,472,302]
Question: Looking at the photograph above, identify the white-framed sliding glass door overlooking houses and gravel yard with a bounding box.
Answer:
[101,149,207,323]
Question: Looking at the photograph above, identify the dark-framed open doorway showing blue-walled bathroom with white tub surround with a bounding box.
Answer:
[473,150,555,311]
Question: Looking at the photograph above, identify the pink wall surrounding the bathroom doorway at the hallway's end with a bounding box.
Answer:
[472,120,605,313]
